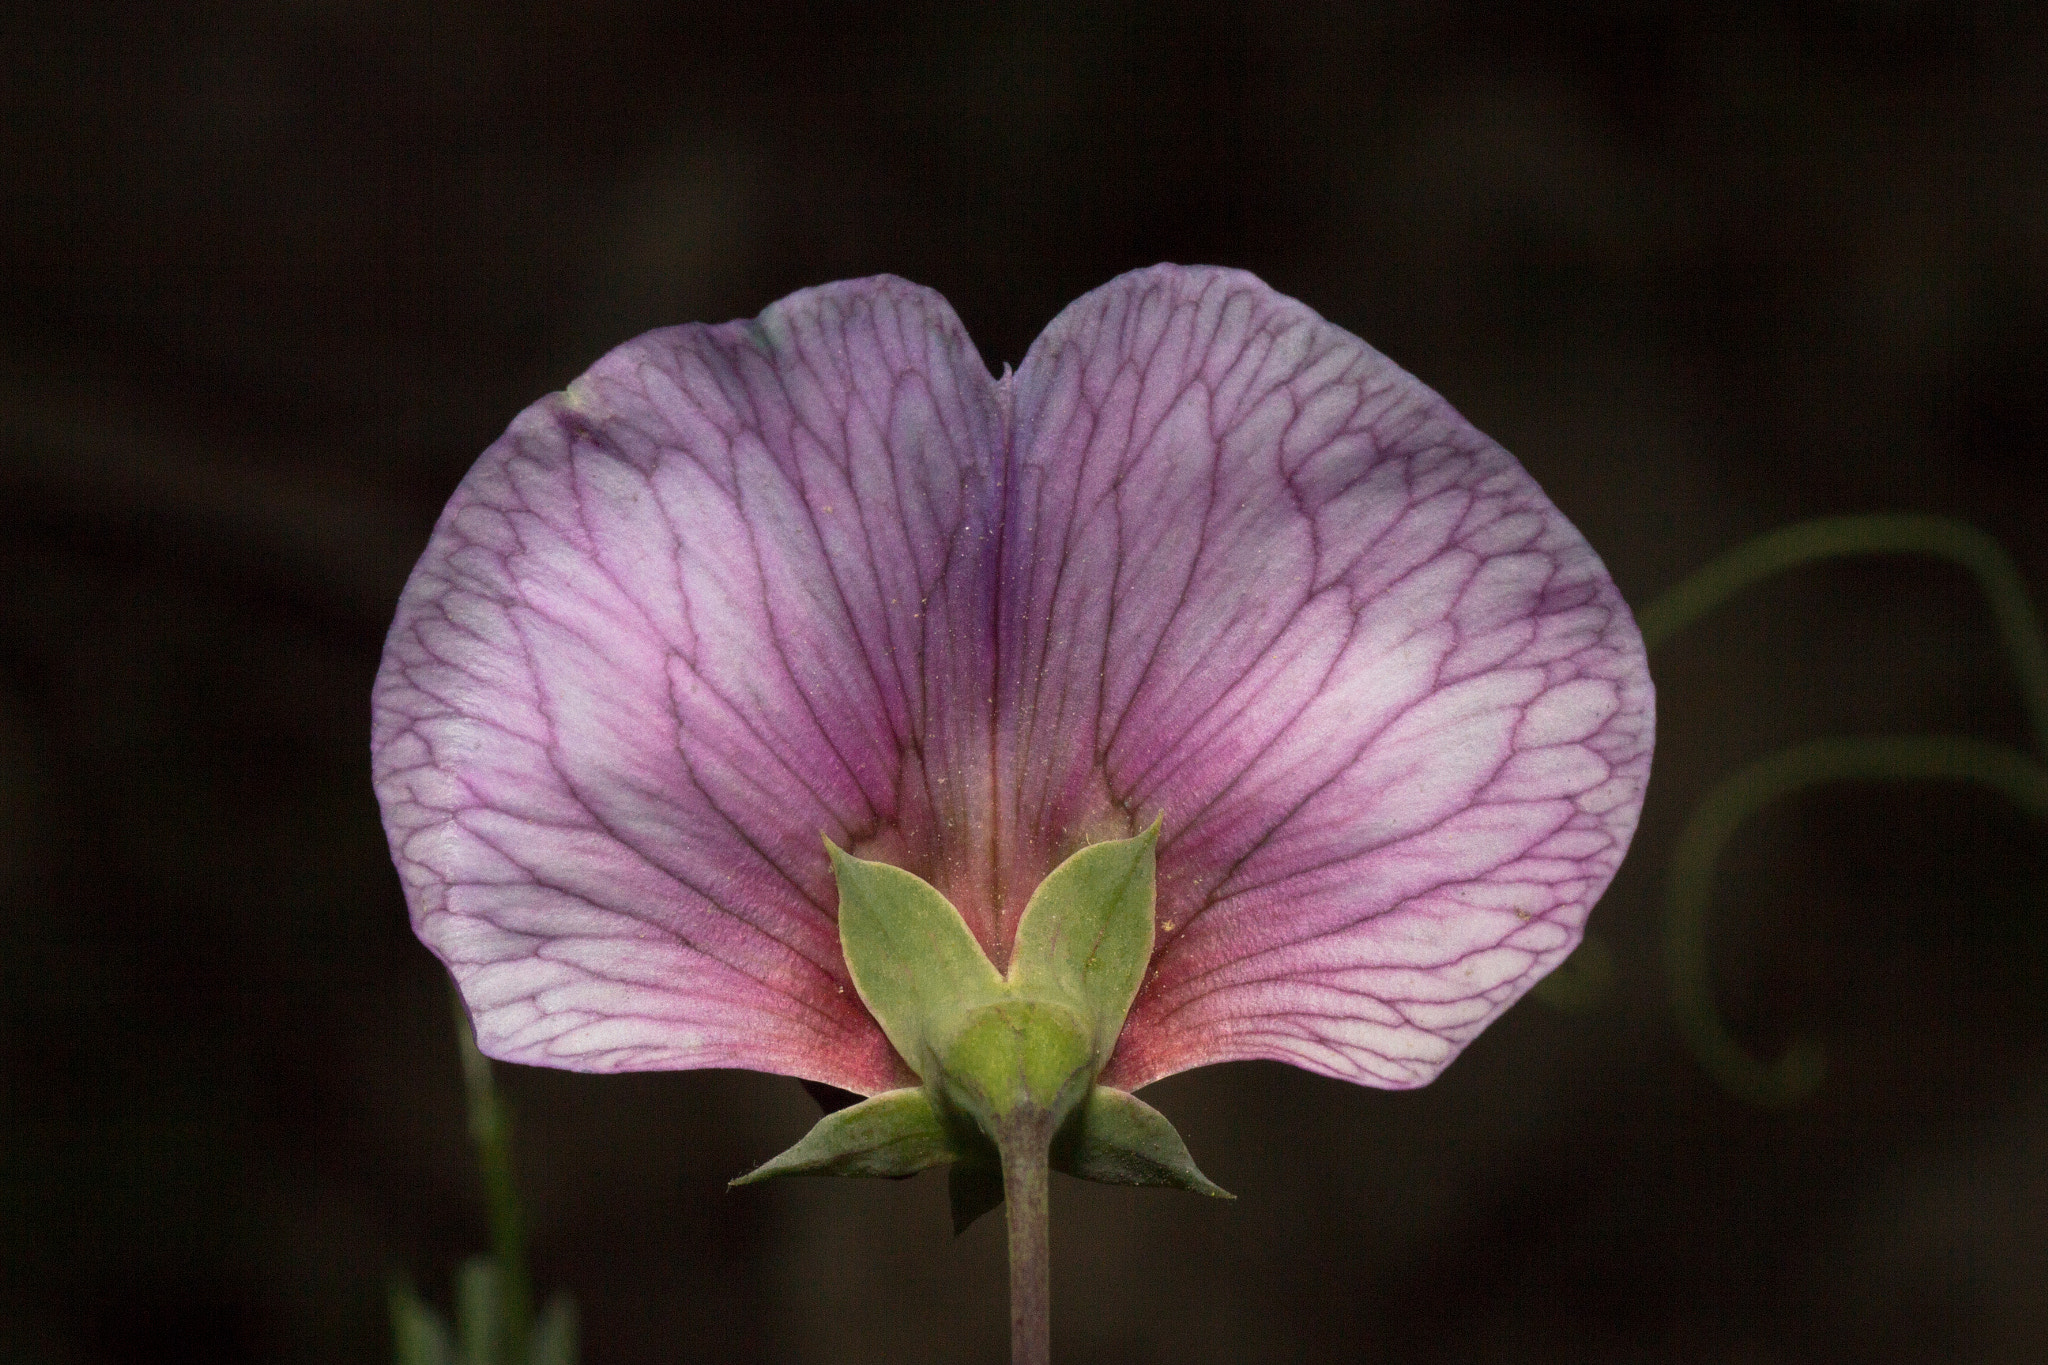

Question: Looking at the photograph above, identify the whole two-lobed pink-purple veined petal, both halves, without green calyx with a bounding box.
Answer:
[373,266,1653,1095]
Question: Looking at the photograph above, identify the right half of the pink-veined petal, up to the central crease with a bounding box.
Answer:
[997,266,1653,1089]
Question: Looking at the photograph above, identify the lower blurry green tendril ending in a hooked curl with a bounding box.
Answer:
[1665,735,2048,1105]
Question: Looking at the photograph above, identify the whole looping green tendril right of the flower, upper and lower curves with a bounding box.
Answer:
[1638,514,2048,1105]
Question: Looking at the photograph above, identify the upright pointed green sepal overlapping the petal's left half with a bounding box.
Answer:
[825,839,1008,1081]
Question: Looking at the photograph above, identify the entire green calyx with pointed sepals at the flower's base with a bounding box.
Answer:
[733,823,1229,1230]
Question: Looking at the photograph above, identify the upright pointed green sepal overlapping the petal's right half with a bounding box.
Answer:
[1008,821,1159,1064]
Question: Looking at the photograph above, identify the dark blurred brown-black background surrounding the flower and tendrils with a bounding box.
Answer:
[0,0,2048,1365]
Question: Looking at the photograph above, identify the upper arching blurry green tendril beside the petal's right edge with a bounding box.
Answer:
[1636,512,2048,753]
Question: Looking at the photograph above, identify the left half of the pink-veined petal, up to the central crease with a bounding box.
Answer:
[373,278,1006,1093]
